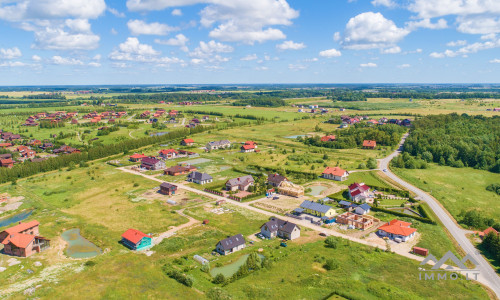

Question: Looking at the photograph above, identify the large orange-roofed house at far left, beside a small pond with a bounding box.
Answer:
[0,220,50,257]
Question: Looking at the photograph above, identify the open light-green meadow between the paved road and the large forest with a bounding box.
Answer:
[393,164,500,224]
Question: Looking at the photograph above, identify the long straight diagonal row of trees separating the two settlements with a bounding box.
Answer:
[0,122,251,183]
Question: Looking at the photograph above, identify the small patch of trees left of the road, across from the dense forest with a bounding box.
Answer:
[297,123,406,149]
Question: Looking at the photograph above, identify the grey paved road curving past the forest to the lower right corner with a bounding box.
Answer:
[379,134,500,298]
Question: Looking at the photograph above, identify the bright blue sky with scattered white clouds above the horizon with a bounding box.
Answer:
[0,0,500,86]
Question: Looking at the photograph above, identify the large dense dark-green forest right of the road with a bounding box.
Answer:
[404,114,500,173]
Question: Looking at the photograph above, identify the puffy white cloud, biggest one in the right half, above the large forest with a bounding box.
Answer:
[341,12,410,50]
